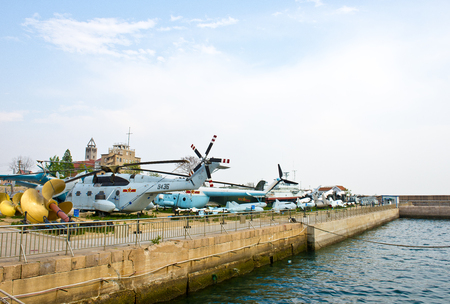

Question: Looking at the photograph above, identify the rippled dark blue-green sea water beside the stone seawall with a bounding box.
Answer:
[171,219,450,303]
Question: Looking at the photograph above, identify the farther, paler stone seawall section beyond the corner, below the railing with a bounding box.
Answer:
[307,209,399,250]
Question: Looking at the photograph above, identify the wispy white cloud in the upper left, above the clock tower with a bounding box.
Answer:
[23,14,156,57]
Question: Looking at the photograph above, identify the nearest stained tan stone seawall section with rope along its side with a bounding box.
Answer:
[0,223,307,303]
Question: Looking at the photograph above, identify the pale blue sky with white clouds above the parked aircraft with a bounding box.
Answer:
[0,0,450,195]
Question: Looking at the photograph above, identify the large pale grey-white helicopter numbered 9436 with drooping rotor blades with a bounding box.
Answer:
[66,135,229,213]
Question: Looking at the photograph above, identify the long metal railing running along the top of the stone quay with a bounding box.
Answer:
[0,205,395,262]
